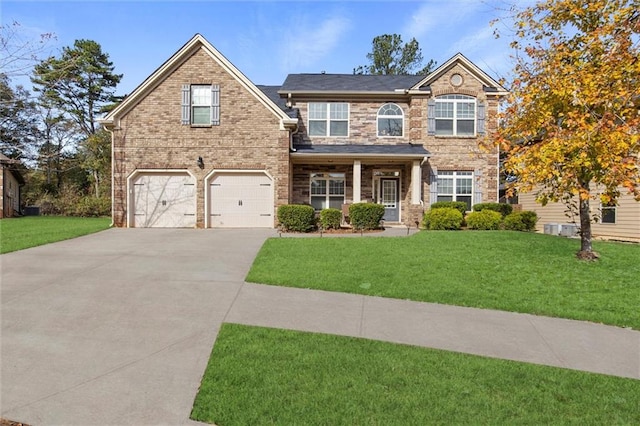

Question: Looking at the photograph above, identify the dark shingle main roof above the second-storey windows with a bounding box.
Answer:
[280,74,425,92]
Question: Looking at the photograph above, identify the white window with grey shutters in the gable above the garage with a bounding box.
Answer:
[182,84,220,126]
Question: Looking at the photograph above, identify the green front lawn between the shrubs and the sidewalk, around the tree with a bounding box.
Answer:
[247,231,640,329]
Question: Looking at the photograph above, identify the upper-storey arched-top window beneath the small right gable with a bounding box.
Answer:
[430,95,484,136]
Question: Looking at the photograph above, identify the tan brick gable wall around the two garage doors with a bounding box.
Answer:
[113,49,289,227]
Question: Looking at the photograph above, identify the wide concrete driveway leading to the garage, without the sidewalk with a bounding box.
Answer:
[0,229,274,425]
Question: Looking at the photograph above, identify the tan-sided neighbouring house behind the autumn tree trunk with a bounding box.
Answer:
[518,188,640,242]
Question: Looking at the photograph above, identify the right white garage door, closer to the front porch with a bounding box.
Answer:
[209,173,273,228]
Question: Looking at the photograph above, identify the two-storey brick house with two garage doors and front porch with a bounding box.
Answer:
[101,34,507,228]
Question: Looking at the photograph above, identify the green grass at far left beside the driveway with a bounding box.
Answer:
[0,216,111,253]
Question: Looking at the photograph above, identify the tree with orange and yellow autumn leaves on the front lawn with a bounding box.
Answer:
[493,0,640,260]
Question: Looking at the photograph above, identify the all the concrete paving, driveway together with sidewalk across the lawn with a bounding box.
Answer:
[0,228,640,425]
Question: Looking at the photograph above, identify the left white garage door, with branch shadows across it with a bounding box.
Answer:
[132,173,196,228]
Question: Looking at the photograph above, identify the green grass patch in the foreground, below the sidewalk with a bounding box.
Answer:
[191,324,640,426]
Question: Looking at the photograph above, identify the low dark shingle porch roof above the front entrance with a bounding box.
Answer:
[295,143,431,157]
